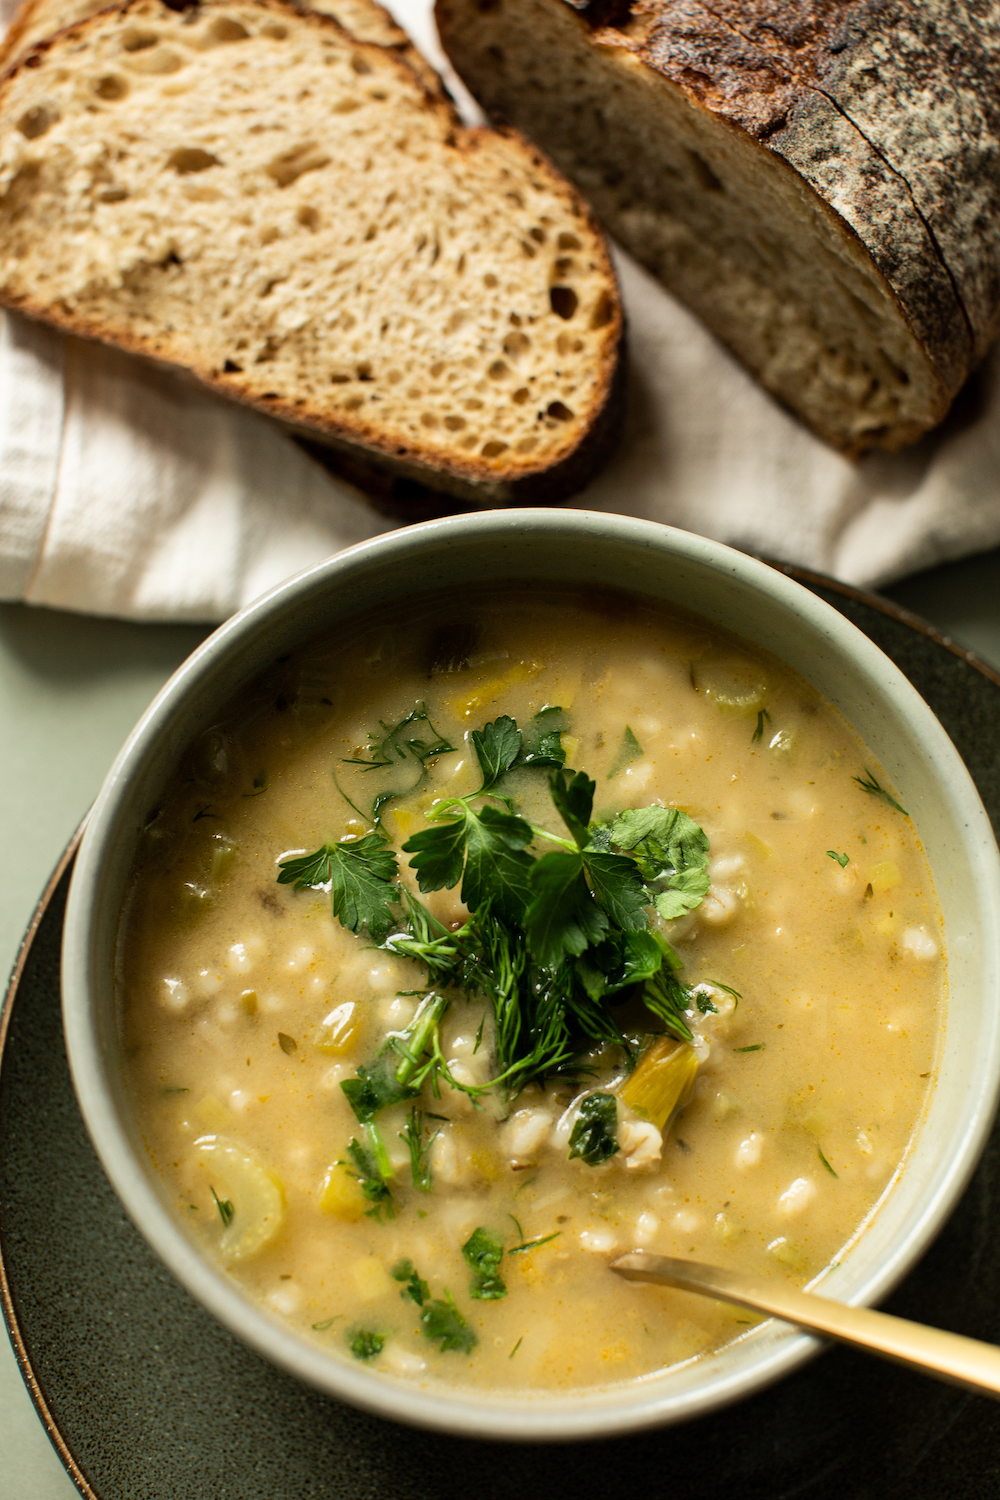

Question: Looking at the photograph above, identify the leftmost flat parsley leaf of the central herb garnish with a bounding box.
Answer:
[277,834,399,942]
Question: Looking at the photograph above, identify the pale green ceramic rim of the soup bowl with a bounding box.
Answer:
[63,509,1000,1442]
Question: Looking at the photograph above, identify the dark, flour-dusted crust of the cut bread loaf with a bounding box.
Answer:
[436,0,1000,452]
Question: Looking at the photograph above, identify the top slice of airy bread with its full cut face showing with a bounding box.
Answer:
[0,0,622,506]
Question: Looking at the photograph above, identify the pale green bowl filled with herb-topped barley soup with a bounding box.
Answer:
[63,510,1000,1440]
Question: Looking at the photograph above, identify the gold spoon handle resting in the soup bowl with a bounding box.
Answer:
[612,1250,1000,1400]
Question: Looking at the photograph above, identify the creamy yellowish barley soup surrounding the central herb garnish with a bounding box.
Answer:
[120,588,945,1391]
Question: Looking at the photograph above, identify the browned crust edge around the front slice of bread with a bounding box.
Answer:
[0,0,624,515]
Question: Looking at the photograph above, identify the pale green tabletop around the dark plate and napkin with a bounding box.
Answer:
[0,552,1000,1500]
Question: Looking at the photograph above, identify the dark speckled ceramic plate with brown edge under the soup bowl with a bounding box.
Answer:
[0,569,1000,1500]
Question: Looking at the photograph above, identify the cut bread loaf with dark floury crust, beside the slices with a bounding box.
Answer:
[436,0,1000,453]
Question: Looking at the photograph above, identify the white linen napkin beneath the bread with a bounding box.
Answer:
[0,0,1000,621]
